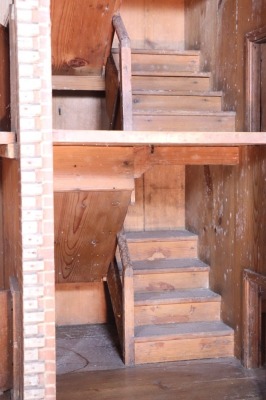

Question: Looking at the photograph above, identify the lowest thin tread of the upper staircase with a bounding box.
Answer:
[133,108,236,117]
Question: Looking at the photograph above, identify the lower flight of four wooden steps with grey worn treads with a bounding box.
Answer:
[115,230,234,364]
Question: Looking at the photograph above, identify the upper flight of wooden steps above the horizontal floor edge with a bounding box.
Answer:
[111,50,235,132]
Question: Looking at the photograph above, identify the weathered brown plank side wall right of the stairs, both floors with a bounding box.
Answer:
[185,0,266,358]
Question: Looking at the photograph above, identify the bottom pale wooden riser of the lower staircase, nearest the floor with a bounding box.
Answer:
[135,335,234,364]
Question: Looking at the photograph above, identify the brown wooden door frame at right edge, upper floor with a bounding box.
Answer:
[246,26,266,132]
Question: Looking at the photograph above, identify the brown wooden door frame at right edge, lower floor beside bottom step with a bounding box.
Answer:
[243,270,266,368]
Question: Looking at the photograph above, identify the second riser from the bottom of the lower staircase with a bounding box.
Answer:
[135,301,220,326]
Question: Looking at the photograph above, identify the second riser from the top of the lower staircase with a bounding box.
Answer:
[134,271,209,292]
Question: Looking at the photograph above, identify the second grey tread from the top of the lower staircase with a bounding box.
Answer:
[133,258,210,275]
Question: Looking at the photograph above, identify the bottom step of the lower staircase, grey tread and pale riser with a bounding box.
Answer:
[135,321,234,364]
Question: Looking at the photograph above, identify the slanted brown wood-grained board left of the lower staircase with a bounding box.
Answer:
[55,191,131,283]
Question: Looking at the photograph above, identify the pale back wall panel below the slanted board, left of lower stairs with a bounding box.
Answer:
[55,282,110,326]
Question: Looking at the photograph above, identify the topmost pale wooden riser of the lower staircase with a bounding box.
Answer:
[128,239,197,261]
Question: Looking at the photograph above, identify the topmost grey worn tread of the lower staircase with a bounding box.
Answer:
[126,229,198,243]
